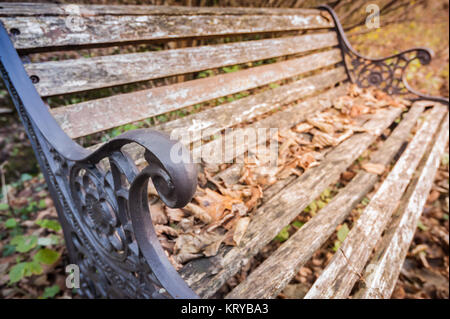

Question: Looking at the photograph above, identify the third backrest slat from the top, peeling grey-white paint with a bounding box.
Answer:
[25,32,337,96]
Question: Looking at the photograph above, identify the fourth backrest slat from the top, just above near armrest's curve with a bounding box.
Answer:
[51,49,341,138]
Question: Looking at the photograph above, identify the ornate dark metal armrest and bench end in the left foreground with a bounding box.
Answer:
[0,25,198,298]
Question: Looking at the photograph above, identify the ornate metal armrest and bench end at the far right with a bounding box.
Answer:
[319,5,449,104]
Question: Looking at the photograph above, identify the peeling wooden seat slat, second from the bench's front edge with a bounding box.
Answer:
[305,105,446,299]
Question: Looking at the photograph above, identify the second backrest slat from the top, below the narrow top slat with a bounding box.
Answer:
[0,14,332,49]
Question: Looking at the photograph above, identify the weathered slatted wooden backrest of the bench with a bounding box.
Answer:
[0,3,346,145]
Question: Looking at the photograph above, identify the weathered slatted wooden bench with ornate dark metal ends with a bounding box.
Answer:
[0,3,448,298]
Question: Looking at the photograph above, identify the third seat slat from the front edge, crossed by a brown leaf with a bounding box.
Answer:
[227,103,424,299]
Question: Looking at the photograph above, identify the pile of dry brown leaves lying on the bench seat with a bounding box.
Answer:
[149,85,406,269]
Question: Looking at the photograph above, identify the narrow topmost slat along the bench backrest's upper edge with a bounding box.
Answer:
[0,2,331,19]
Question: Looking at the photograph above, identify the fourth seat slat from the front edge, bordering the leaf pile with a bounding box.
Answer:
[180,108,401,298]
